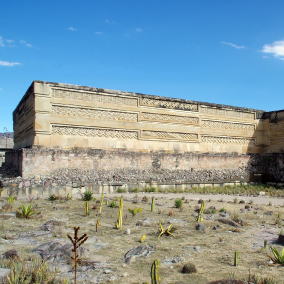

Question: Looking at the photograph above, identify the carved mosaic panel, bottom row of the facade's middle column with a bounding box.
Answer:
[141,130,198,140]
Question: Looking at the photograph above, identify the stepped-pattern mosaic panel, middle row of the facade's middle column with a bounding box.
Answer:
[141,112,199,124]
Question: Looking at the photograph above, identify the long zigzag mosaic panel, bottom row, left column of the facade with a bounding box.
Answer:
[52,125,138,139]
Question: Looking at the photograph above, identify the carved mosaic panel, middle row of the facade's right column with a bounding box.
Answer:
[201,120,255,131]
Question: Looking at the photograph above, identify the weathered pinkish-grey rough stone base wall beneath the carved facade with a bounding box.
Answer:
[3,148,272,180]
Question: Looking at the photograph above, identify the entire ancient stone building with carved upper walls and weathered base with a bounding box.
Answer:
[6,81,284,186]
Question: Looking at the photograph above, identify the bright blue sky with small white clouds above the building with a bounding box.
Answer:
[0,0,284,132]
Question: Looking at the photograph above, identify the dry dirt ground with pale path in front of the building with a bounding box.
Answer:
[0,193,284,284]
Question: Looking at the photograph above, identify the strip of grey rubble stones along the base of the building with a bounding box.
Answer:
[0,162,258,188]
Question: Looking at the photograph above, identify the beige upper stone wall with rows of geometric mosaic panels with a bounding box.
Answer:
[13,81,264,154]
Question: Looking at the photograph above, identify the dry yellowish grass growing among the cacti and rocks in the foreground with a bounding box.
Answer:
[0,193,284,284]
